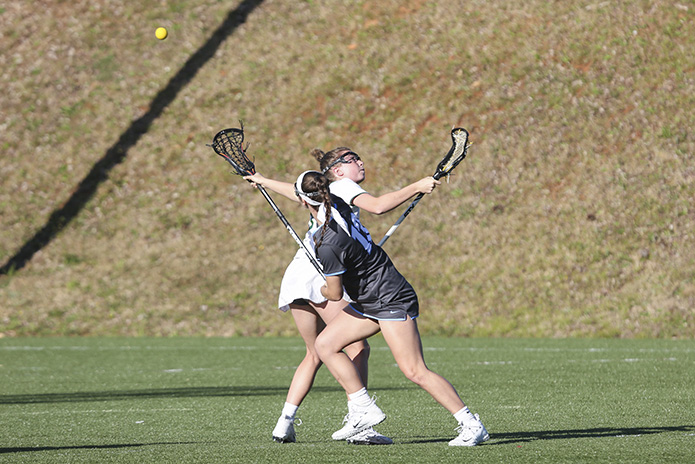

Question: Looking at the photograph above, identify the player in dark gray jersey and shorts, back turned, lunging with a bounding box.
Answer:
[295,171,490,446]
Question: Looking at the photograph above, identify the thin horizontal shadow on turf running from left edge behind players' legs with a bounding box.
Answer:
[0,385,411,404]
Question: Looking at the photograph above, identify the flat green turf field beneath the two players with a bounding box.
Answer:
[0,337,695,463]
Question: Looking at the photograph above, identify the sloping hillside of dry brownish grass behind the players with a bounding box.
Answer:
[0,0,695,338]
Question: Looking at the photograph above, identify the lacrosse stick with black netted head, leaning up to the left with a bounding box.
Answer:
[208,124,325,279]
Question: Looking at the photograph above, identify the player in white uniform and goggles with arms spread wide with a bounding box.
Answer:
[244,147,440,444]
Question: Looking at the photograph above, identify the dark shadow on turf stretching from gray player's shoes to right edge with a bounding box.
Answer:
[398,425,695,446]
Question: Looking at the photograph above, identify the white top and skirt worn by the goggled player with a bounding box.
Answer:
[278,179,367,311]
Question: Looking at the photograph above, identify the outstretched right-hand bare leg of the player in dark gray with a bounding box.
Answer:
[378,318,464,414]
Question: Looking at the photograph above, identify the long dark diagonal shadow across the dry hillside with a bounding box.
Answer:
[0,0,263,275]
